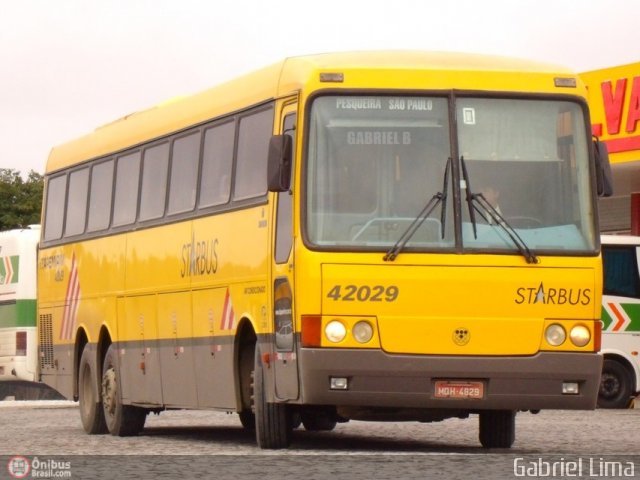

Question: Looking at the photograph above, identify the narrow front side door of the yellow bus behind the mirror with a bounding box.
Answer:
[271,102,299,400]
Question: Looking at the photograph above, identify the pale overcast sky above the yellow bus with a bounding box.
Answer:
[0,0,640,176]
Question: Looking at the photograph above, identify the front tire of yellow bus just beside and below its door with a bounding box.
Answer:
[253,348,292,449]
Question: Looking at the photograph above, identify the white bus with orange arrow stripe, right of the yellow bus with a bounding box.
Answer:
[598,235,640,408]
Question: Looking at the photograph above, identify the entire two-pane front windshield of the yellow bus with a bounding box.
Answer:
[305,95,595,254]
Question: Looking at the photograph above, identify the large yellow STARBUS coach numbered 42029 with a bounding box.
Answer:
[38,51,608,448]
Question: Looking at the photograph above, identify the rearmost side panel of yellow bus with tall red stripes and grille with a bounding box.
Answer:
[38,235,125,398]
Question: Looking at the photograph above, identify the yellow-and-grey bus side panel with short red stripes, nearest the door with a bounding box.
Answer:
[187,205,271,409]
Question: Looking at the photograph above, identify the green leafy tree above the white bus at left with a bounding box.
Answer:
[0,168,44,230]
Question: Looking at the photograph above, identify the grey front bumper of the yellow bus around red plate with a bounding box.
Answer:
[300,349,602,410]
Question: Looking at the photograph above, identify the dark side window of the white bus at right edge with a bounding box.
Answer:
[602,245,640,298]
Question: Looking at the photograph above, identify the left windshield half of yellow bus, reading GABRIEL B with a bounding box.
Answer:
[306,96,454,248]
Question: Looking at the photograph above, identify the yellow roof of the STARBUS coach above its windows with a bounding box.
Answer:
[47,51,584,173]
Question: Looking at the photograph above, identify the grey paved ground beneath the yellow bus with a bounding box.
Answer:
[0,401,640,480]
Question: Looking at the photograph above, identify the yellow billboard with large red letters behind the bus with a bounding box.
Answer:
[580,63,640,162]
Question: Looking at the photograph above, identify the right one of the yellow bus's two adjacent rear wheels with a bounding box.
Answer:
[102,344,147,437]
